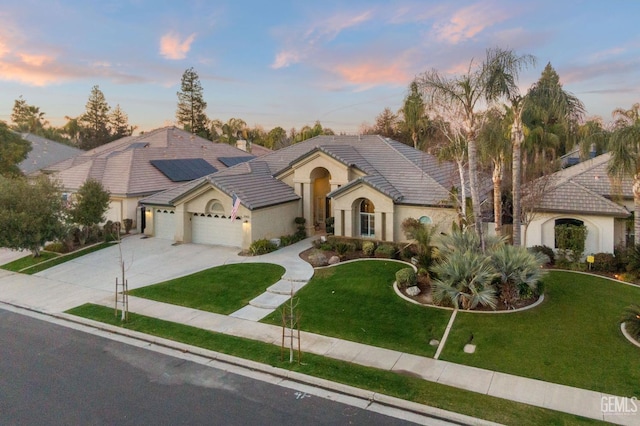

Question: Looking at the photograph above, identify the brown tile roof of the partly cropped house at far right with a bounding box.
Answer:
[523,154,633,217]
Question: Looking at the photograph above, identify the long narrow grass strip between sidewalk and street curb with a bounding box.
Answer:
[67,304,601,426]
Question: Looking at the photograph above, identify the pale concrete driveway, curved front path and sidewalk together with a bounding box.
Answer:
[0,237,640,425]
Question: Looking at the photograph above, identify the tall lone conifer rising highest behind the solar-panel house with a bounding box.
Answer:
[176,67,209,137]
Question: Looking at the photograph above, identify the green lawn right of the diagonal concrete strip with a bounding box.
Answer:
[440,271,640,397]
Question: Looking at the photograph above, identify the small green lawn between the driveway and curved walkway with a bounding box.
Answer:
[129,263,285,315]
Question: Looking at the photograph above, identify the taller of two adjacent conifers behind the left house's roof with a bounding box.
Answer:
[80,85,111,149]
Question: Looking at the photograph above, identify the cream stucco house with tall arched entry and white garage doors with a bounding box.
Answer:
[141,135,491,249]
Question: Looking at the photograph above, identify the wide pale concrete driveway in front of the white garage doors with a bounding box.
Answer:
[35,235,250,291]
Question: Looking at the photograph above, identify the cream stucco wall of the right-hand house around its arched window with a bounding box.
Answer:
[522,213,616,254]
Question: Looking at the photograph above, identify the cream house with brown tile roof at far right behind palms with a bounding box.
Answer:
[522,154,633,254]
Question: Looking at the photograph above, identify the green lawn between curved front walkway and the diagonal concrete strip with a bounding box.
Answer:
[263,260,451,357]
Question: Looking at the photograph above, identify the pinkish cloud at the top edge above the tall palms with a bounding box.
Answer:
[434,3,509,44]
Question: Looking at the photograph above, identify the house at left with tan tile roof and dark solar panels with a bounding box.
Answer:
[45,127,264,230]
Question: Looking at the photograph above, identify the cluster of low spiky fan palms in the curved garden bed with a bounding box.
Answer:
[430,229,548,310]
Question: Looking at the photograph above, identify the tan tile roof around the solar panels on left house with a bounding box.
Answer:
[48,126,262,196]
